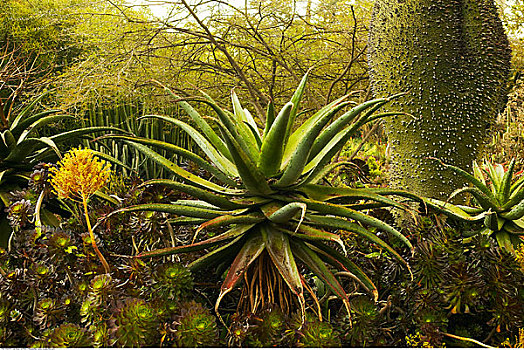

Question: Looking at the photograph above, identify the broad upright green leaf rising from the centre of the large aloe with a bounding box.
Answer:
[257,102,293,177]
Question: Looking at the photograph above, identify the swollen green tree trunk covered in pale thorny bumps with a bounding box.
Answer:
[369,0,511,199]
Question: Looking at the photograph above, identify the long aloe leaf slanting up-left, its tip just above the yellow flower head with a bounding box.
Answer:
[126,141,243,195]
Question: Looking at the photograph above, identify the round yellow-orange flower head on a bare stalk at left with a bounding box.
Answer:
[50,148,111,200]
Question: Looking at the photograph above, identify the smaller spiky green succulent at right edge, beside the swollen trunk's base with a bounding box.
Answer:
[427,158,524,253]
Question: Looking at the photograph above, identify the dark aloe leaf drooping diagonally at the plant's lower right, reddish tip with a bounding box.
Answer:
[311,241,378,301]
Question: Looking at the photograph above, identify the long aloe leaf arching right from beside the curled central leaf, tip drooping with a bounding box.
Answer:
[294,199,413,250]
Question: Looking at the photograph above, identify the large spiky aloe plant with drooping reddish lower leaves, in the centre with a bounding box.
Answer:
[106,74,418,315]
